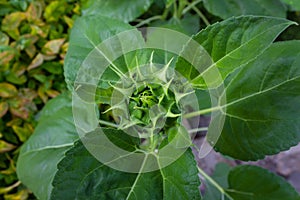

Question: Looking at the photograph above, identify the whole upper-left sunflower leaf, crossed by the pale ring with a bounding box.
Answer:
[64,15,149,103]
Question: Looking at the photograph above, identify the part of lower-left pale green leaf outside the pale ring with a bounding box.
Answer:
[17,95,78,199]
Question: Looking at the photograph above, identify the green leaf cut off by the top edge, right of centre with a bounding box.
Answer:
[204,0,286,19]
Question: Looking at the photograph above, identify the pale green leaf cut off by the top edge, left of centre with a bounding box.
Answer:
[82,0,153,22]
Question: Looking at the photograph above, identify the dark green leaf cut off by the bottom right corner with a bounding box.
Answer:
[204,165,300,200]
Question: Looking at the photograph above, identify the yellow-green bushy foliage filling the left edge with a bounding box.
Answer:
[0,0,81,200]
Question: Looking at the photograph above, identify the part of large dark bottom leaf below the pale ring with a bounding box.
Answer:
[51,129,201,200]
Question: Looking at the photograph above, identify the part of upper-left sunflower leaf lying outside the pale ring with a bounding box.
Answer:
[64,16,139,90]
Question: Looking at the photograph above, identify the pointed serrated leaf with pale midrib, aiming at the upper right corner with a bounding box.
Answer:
[176,16,293,88]
